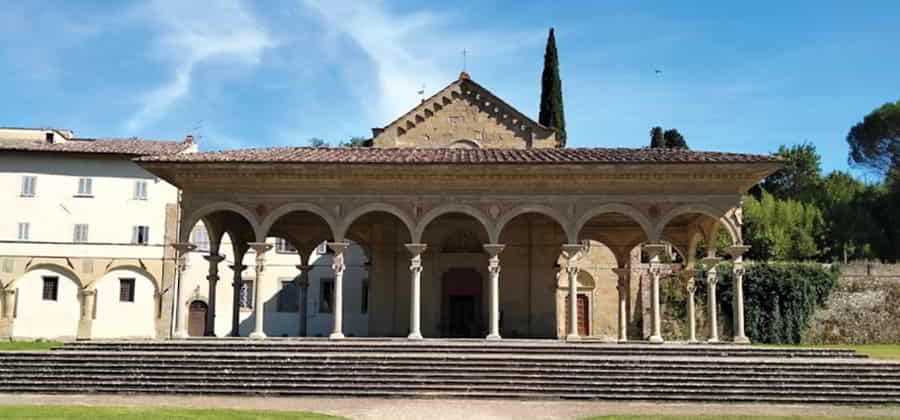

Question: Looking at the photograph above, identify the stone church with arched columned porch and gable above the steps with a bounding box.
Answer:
[137,73,781,342]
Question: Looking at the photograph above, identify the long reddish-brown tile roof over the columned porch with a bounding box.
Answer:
[138,147,781,164]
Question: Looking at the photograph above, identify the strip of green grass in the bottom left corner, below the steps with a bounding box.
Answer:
[0,405,339,420]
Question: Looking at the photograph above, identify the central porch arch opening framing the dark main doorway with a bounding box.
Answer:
[422,212,492,337]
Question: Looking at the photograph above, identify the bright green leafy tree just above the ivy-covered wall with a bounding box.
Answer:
[744,191,824,261]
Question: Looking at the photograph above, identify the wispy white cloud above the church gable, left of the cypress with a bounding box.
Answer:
[302,0,546,122]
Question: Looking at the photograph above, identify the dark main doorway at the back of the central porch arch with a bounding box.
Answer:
[441,268,484,338]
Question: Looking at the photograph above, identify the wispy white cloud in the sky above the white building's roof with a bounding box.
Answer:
[126,0,275,132]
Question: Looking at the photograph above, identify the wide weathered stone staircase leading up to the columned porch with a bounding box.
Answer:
[0,339,900,404]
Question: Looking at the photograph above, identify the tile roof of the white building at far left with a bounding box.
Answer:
[0,139,191,156]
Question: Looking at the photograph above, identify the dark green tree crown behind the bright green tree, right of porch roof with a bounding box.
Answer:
[757,142,822,203]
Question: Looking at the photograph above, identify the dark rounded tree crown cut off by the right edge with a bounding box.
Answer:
[847,101,900,176]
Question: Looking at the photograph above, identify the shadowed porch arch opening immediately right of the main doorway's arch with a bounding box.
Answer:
[498,211,567,338]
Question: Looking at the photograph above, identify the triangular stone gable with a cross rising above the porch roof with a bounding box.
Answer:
[373,73,559,149]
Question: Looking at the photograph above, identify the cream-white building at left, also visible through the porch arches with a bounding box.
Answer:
[0,128,368,339]
